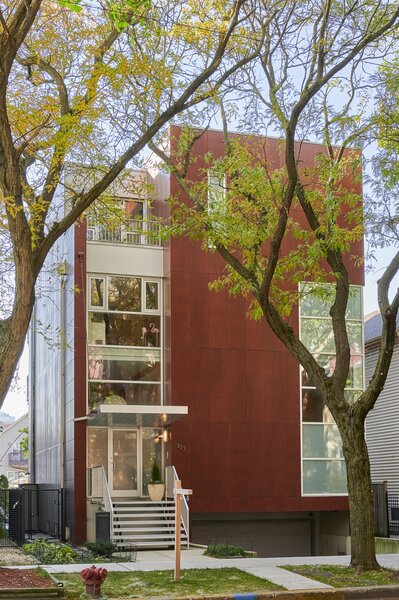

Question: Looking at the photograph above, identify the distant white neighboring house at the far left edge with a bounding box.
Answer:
[0,414,28,485]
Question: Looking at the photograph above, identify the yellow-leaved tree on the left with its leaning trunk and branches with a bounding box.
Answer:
[0,0,260,406]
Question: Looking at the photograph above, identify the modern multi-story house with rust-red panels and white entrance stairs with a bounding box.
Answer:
[30,127,363,556]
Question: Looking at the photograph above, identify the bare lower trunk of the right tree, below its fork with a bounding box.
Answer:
[341,417,380,570]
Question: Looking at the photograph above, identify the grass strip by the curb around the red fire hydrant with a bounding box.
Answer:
[56,568,284,600]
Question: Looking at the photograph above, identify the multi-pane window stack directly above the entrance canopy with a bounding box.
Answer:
[88,275,162,410]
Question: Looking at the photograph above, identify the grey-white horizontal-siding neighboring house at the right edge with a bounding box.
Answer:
[364,313,399,493]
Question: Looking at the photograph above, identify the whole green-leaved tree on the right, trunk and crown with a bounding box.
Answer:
[153,0,399,569]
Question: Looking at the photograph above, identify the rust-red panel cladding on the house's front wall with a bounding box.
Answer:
[169,126,364,513]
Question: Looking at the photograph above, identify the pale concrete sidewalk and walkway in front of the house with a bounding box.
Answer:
[23,548,399,590]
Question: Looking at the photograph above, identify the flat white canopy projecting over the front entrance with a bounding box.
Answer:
[87,404,188,428]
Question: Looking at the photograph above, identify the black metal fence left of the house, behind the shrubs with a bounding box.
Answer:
[0,485,64,546]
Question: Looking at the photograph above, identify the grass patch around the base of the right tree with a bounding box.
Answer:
[283,565,399,588]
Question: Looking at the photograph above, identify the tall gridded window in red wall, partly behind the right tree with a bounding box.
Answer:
[300,283,363,496]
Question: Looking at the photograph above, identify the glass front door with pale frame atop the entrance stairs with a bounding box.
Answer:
[109,429,141,496]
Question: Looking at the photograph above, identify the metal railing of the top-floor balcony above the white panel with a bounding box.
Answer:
[86,219,162,246]
